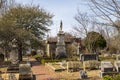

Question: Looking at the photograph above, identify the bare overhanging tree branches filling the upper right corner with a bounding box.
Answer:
[89,0,120,33]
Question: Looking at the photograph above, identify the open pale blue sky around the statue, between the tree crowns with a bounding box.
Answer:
[16,0,87,36]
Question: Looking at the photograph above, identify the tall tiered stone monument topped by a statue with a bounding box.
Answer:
[55,21,67,59]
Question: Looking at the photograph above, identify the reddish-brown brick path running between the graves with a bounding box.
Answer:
[32,62,58,80]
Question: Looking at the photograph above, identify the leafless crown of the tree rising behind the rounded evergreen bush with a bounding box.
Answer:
[73,10,90,37]
